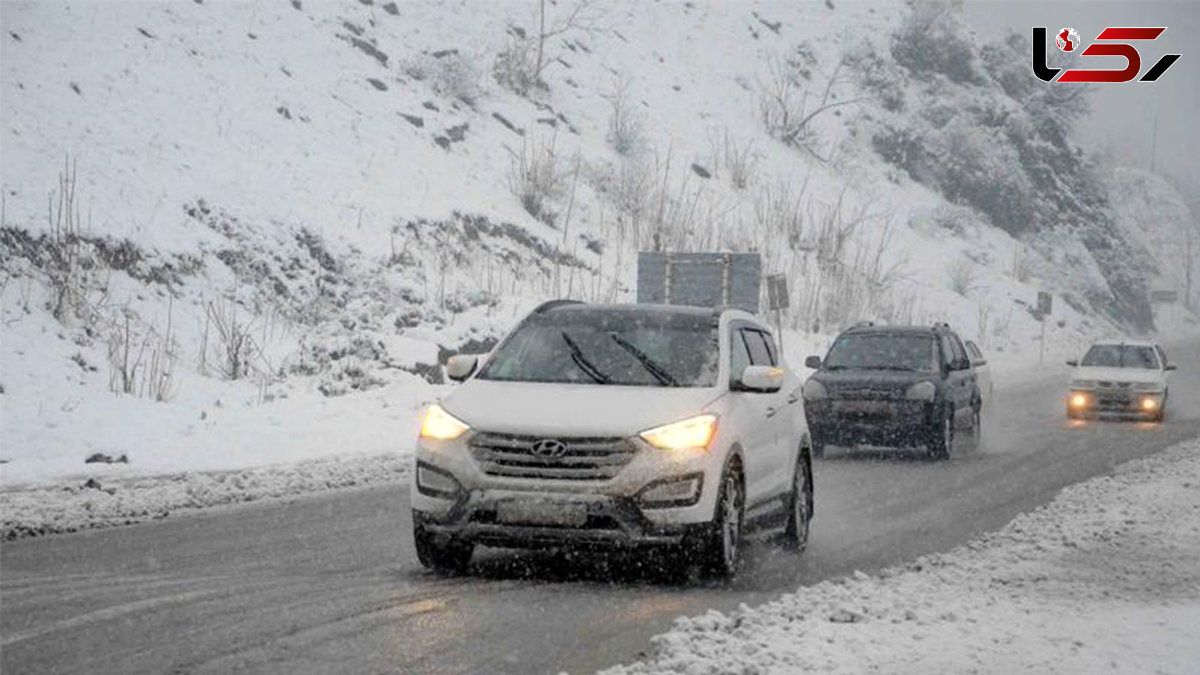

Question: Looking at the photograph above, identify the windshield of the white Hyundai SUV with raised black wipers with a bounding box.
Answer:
[479,310,719,387]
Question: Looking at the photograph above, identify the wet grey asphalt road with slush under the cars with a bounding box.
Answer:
[0,345,1200,675]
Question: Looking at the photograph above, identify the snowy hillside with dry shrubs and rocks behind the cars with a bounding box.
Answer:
[0,0,1192,494]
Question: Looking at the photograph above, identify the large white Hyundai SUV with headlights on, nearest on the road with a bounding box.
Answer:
[412,300,812,578]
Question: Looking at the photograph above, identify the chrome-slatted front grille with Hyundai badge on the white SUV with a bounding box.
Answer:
[470,432,637,480]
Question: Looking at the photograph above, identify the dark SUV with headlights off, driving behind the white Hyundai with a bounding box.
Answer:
[804,323,982,459]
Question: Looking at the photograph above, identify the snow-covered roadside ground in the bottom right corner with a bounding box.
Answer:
[605,440,1200,675]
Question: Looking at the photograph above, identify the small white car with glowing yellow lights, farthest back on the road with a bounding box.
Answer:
[1067,340,1175,422]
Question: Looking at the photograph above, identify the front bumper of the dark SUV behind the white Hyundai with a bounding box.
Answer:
[804,399,935,447]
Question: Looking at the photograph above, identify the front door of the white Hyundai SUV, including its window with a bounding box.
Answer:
[730,322,775,512]
